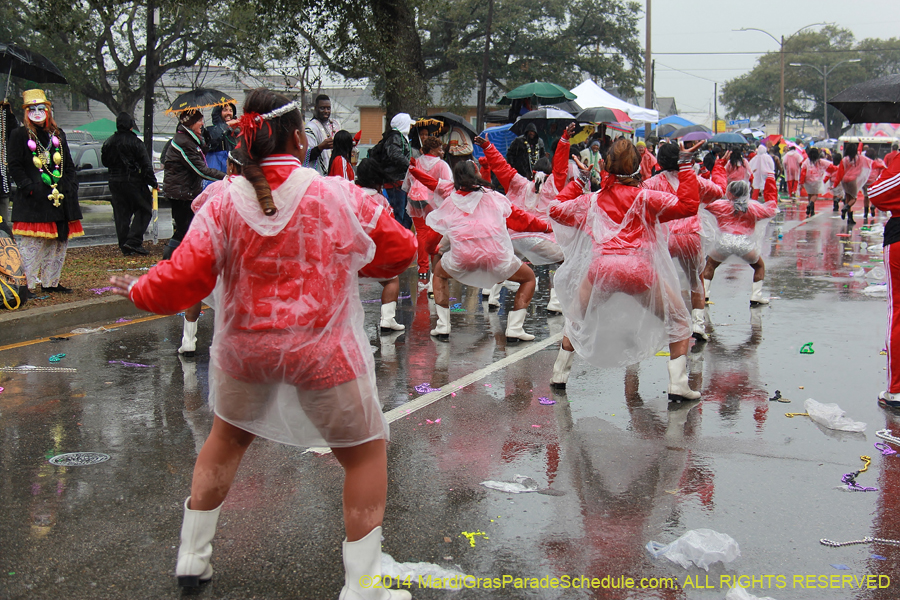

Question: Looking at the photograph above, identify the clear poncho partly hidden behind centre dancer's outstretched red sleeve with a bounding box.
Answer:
[506,173,564,265]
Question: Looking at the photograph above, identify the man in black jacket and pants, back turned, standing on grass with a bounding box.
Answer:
[101,112,159,256]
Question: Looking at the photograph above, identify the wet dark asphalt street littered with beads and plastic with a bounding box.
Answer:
[0,202,900,600]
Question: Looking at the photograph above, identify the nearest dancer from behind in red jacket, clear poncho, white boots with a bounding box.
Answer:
[112,89,416,600]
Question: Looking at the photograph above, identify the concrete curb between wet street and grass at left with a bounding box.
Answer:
[0,296,150,344]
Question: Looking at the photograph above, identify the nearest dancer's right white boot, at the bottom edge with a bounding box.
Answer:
[338,527,412,600]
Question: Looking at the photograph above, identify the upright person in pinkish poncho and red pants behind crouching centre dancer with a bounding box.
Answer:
[403,135,453,284]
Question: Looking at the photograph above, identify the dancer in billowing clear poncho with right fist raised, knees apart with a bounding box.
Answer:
[550,138,700,401]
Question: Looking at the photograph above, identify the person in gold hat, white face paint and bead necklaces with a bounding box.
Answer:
[7,90,84,294]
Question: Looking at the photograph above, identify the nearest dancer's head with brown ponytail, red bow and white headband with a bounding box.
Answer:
[234,88,303,217]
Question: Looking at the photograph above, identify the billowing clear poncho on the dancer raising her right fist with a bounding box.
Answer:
[550,186,691,367]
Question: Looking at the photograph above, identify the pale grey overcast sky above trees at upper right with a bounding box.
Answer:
[637,0,900,125]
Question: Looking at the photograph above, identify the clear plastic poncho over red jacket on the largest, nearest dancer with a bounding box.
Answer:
[182,169,388,447]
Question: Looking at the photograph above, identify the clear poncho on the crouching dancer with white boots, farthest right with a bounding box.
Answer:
[699,177,777,265]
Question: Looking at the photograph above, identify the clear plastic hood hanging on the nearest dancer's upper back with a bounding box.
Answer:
[228,167,318,237]
